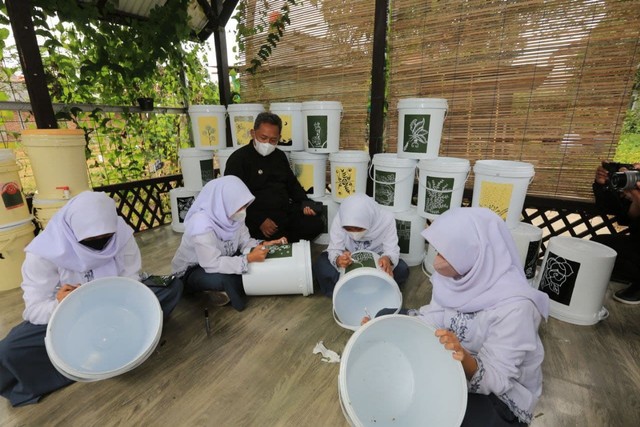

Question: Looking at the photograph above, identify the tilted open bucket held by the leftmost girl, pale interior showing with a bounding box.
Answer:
[44,277,162,381]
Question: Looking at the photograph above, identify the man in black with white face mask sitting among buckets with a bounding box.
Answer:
[224,113,324,242]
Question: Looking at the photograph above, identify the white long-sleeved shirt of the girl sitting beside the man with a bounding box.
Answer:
[171,226,260,274]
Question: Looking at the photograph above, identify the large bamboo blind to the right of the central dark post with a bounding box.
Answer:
[385,0,640,198]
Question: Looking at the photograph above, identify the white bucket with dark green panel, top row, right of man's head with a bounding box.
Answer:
[302,101,342,153]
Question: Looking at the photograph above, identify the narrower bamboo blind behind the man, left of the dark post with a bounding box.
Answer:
[240,0,375,150]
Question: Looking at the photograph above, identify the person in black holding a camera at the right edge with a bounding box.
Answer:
[593,162,640,304]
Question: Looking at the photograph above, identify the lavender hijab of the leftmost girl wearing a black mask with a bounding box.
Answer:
[25,191,133,278]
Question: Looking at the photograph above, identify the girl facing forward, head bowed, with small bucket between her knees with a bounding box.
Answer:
[313,194,409,297]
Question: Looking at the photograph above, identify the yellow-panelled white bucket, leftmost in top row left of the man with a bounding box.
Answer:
[189,105,227,150]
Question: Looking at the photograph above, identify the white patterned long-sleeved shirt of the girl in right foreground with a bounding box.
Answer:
[418,300,544,423]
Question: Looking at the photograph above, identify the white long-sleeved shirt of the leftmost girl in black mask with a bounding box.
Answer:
[22,236,142,325]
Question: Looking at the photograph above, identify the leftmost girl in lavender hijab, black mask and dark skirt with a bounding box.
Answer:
[0,191,182,406]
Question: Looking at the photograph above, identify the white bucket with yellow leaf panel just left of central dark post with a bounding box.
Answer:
[329,150,369,203]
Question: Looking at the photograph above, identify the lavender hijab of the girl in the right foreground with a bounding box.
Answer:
[422,208,549,318]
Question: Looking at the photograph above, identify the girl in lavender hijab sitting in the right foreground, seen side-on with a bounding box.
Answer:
[363,208,549,427]
